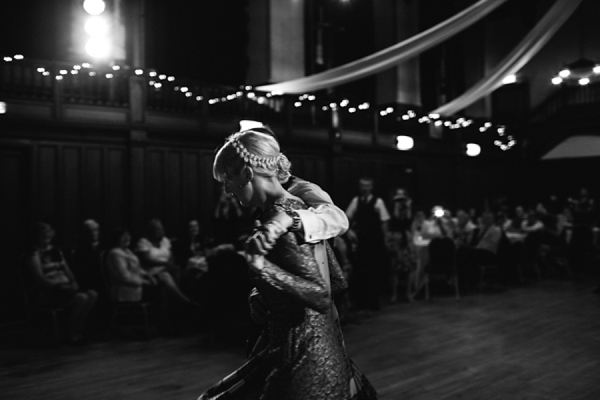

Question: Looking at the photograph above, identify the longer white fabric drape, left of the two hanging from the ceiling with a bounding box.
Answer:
[255,0,506,93]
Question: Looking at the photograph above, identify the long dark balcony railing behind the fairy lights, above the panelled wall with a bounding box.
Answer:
[0,59,432,141]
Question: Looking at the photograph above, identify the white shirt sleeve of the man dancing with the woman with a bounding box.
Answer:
[290,181,349,243]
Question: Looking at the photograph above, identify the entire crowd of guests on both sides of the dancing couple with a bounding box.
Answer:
[10,178,600,344]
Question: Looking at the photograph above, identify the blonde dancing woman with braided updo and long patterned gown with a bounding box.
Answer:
[200,130,376,400]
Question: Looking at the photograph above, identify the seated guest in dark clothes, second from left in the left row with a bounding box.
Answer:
[71,219,105,300]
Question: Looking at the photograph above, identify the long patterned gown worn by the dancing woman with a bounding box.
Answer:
[199,199,377,400]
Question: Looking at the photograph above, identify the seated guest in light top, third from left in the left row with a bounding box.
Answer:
[106,228,157,302]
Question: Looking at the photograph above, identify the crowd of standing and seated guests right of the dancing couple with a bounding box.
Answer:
[335,178,600,319]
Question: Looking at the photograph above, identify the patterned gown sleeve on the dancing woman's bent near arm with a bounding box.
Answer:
[257,214,331,313]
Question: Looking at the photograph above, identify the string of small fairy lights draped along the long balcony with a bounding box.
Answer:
[3,54,517,151]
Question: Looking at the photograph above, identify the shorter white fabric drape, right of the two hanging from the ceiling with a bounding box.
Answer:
[431,0,582,116]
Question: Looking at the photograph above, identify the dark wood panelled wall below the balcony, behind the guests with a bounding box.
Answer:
[0,126,519,258]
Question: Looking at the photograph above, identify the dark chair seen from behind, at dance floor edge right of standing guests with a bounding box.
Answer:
[425,238,460,300]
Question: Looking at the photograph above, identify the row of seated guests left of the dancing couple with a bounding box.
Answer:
[20,198,251,345]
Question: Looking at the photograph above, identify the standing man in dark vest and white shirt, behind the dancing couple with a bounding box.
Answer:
[346,177,390,311]
